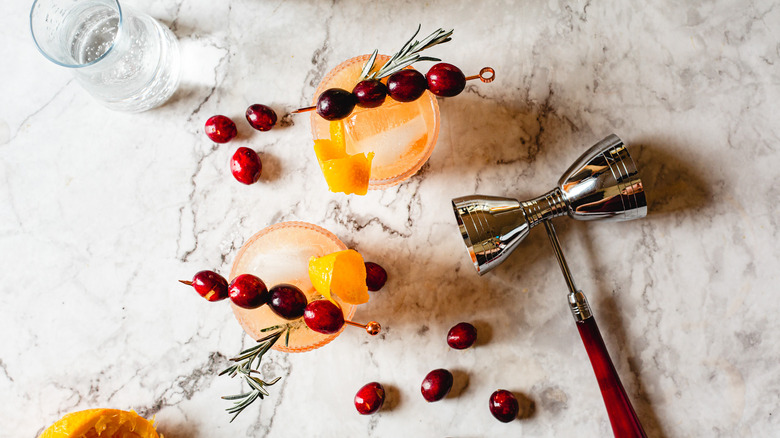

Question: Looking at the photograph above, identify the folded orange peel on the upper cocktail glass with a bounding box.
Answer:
[314,120,374,195]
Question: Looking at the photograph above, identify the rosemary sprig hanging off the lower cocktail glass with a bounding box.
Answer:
[219,324,290,423]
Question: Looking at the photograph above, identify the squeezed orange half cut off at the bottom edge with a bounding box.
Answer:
[40,409,162,438]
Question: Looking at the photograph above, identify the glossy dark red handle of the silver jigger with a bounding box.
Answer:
[577,316,647,438]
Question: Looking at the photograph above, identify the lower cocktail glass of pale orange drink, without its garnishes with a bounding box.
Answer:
[230,222,355,353]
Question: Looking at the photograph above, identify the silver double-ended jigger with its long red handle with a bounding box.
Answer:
[452,134,647,438]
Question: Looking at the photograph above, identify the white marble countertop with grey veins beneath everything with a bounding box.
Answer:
[0,0,780,438]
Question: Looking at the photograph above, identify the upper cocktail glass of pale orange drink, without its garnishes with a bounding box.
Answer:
[311,55,440,189]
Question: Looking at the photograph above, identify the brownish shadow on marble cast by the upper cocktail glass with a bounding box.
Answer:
[431,87,587,193]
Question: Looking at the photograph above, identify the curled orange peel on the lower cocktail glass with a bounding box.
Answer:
[309,249,368,304]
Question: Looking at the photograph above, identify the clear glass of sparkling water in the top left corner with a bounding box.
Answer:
[30,0,180,112]
